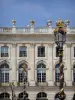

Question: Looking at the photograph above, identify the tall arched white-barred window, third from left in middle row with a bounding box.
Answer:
[37,63,46,82]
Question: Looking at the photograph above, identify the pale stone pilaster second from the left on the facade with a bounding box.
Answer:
[29,44,35,86]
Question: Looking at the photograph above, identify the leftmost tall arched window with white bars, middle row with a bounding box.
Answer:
[0,63,9,83]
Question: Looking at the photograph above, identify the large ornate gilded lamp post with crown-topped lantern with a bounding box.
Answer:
[54,19,66,100]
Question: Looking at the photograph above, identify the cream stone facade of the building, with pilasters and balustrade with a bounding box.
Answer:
[0,22,75,100]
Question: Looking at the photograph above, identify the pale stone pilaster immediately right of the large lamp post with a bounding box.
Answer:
[66,43,72,86]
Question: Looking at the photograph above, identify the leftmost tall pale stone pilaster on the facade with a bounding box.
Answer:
[11,44,17,85]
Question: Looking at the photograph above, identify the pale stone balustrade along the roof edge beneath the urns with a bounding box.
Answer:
[0,27,75,34]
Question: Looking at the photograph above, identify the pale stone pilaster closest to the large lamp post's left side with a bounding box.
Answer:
[47,44,54,86]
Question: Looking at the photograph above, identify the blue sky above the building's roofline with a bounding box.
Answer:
[0,0,75,27]
